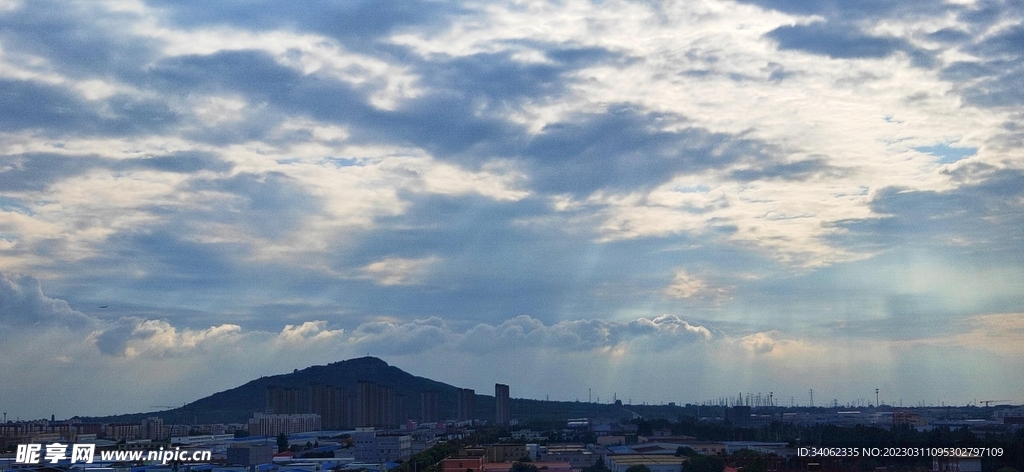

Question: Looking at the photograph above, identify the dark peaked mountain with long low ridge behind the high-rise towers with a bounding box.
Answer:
[79,356,683,425]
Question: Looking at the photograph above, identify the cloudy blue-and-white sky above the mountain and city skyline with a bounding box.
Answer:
[0,0,1024,419]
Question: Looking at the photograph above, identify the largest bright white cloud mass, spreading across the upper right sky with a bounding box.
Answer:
[392,1,1019,267]
